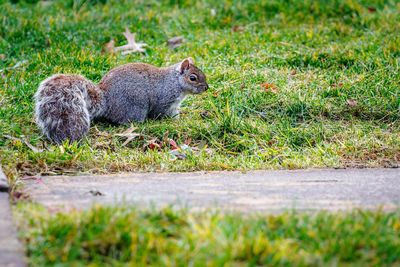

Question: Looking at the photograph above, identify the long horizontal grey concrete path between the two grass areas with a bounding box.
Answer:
[26,169,400,212]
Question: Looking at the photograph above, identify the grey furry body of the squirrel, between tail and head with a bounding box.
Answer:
[99,63,183,124]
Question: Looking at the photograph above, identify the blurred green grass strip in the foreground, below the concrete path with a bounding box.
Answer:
[16,204,400,266]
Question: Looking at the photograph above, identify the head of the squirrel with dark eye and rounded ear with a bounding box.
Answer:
[177,57,208,94]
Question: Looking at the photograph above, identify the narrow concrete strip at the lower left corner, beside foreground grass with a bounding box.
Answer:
[0,168,25,267]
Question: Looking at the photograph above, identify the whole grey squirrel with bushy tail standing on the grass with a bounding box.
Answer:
[35,58,208,143]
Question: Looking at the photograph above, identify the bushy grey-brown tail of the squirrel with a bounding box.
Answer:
[35,74,102,143]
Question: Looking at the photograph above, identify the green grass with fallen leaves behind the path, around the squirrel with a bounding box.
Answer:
[0,0,400,182]
